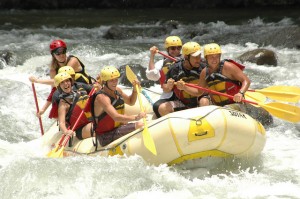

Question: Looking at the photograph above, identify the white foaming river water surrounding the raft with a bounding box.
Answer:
[0,9,300,199]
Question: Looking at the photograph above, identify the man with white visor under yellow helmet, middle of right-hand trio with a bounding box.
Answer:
[155,42,204,117]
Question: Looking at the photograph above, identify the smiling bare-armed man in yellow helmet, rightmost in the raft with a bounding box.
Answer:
[178,43,251,106]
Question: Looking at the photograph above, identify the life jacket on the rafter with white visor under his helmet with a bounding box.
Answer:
[166,60,203,107]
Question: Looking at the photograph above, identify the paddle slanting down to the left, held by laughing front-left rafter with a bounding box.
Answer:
[47,87,96,158]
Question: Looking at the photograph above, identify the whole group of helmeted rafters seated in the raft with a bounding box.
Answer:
[29,36,271,146]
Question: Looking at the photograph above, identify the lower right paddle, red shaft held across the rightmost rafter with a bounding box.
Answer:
[185,83,300,122]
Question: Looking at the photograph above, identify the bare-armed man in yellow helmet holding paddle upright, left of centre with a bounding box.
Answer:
[91,66,146,146]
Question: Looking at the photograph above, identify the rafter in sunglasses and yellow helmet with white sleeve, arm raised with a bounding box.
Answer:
[146,36,183,115]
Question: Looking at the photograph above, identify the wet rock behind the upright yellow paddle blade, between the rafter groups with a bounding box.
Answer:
[118,64,157,88]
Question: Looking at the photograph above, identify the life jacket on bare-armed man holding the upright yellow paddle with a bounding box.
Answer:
[92,90,125,134]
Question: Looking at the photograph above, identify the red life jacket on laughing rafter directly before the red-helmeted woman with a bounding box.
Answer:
[59,88,93,130]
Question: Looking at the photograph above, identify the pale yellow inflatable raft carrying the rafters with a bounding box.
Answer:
[43,88,266,165]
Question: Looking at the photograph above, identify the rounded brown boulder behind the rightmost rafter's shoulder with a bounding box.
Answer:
[237,49,277,66]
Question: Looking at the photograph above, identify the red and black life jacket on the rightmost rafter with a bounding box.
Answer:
[205,59,245,106]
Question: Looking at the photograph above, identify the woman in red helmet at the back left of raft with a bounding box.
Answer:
[29,39,94,119]
